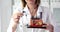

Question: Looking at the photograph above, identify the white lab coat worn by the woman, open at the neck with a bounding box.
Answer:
[7,5,54,32]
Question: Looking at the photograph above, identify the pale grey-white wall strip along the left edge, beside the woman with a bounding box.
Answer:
[1,0,12,32]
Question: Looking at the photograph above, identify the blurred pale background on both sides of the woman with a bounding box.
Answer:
[0,0,60,32]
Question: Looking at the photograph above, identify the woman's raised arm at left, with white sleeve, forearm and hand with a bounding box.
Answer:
[7,12,23,32]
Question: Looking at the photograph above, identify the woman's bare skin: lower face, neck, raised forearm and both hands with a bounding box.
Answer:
[12,0,54,32]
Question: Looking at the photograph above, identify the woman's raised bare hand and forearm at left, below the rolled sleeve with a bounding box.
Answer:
[12,12,23,32]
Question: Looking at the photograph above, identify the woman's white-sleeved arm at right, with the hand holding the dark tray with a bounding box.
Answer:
[43,7,54,32]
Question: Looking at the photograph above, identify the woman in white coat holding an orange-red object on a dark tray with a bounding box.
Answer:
[7,0,54,32]
